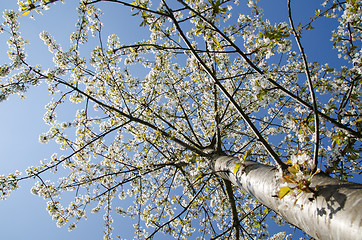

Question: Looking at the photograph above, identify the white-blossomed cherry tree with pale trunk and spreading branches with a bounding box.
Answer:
[0,0,362,239]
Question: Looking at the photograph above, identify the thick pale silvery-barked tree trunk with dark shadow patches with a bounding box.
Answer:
[212,155,362,240]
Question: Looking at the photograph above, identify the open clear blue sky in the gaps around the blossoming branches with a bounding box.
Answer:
[0,0,356,240]
